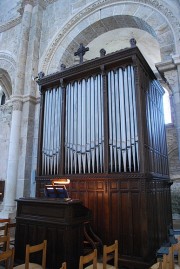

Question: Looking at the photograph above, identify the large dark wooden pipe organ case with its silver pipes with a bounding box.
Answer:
[36,47,172,269]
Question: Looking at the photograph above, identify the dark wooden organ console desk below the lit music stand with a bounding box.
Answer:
[15,198,90,269]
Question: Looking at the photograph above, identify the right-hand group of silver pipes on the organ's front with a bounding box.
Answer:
[108,66,139,172]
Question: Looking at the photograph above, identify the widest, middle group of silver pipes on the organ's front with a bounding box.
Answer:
[65,75,104,174]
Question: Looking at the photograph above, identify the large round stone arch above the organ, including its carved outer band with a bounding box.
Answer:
[40,0,179,74]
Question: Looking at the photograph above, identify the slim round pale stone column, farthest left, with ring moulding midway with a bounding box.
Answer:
[0,0,32,217]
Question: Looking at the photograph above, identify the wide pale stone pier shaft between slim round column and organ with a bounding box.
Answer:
[17,1,44,197]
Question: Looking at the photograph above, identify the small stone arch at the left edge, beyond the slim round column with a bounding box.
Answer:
[0,52,16,95]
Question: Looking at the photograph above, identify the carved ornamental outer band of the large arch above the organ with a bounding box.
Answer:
[41,0,180,73]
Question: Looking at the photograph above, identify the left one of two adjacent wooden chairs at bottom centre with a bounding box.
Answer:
[79,249,97,269]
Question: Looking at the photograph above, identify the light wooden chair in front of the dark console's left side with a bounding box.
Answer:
[14,240,47,269]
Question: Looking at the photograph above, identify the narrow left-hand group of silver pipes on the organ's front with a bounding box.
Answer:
[42,88,62,175]
